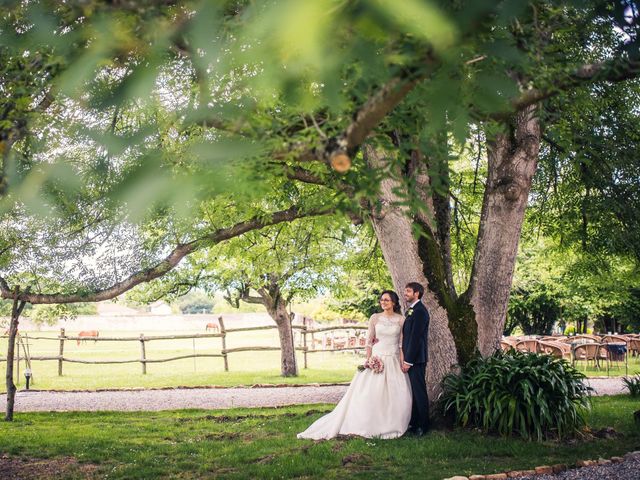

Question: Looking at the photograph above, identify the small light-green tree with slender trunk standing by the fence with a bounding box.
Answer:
[136,217,360,377]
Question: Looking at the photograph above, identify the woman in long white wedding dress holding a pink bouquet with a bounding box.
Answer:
[298,290,411,440]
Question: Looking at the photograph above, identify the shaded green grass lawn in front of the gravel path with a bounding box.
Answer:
[0,396,640,479]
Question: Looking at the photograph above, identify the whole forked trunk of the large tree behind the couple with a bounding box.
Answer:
[364,106,540,399]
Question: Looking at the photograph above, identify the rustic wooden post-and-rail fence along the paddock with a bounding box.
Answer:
[0,317,367,376]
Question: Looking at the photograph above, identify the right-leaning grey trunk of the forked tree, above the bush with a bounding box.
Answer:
[468,106,541,356]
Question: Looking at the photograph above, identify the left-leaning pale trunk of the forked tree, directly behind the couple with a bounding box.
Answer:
[365,146,458,402]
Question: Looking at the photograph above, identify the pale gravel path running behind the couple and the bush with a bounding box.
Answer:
[0,378,624,412]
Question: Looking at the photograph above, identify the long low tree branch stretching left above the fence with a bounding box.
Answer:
[0,206,334,304]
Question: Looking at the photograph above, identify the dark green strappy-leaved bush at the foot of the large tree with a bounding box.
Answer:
[441,350,591,440]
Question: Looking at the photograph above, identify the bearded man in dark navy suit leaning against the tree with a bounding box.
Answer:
[402,282,429,436]
